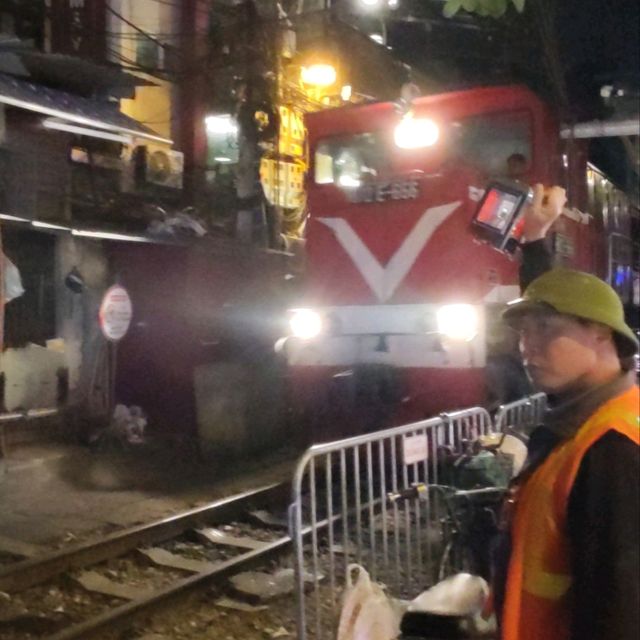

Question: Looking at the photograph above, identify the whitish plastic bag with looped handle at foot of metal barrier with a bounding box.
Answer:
[338,564,400,640]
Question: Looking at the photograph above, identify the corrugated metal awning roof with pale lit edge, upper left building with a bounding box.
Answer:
[0,73,171,144]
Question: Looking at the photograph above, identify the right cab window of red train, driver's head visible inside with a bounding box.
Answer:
[450,111,533,177]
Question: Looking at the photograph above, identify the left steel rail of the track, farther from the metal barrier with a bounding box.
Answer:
[0,483,288,593]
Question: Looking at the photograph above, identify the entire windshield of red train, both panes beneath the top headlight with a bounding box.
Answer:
[314,111,532,188]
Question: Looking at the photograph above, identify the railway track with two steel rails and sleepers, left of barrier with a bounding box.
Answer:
[0,484,291,640]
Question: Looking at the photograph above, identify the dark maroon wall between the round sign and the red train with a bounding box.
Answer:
[112,241,288,456]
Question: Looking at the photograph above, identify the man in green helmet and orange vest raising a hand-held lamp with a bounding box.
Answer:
[495,187,640,640]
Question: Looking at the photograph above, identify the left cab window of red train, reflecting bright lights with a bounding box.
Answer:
[314,133,389,188]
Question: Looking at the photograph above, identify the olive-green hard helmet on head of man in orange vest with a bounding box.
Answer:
[502,268,638,357]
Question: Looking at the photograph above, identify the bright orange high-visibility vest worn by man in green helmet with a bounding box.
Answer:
[502,386,640,640]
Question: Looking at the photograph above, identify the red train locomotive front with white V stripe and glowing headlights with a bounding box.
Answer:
[285,86,630,438]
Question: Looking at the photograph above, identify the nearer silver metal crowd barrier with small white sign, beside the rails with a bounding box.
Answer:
[289,407,495,640]
